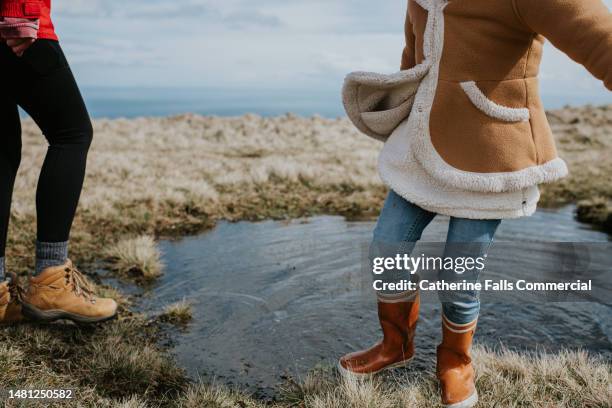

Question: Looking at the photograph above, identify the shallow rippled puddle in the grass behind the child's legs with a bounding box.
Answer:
[142,208,612,395]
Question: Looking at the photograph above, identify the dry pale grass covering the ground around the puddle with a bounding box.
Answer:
[0,107,612,407]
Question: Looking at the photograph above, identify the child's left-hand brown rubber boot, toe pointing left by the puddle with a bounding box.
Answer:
[338,293,419,376]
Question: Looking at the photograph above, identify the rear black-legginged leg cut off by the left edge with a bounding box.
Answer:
[0,51,21,281]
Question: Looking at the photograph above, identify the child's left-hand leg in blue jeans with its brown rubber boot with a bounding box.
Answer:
[338,192,435,375]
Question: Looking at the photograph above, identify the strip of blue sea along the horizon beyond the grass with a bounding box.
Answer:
[81,84,612,118]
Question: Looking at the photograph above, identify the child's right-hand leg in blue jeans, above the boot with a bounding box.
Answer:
[439,217,501,325]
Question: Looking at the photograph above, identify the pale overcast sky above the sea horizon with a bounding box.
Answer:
[53,0,612,99]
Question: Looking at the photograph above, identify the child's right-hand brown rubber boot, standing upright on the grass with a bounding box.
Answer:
[436,315,478,408]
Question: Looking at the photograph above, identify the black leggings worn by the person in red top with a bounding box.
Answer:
[0,40,93,257]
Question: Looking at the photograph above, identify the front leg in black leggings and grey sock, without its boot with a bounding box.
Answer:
[13,40,93,273]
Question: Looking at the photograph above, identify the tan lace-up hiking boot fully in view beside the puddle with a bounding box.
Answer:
[23,260,117,323]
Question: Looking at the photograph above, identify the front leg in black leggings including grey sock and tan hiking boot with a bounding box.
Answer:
[5,40,117,323]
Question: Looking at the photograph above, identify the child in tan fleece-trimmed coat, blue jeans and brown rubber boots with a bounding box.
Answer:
[339,0,612,408]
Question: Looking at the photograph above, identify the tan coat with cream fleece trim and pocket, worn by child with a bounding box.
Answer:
[392,0,612,192]
